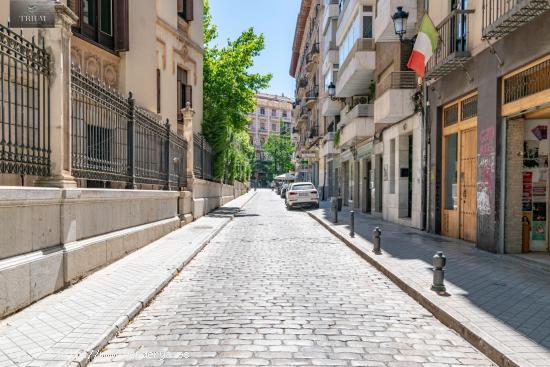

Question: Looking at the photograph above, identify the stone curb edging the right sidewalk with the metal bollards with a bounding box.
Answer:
[307,211,521,367]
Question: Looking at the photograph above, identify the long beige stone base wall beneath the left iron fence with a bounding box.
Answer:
[0,180,247,319]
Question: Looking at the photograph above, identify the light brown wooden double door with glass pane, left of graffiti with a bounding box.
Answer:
[441,93,477,242]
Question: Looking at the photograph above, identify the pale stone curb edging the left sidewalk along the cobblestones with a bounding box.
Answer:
[68,192,256,367]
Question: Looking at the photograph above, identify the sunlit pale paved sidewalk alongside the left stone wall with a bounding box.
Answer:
[0,192,254,367]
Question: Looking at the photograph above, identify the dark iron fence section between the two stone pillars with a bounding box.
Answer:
[71,66,187,189]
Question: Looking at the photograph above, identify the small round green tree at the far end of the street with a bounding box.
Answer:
[262,132,294,178]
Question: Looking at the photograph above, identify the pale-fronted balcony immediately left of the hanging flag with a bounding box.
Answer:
[374,71,417,124]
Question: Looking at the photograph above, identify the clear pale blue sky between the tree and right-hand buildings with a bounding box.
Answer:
[210,0,301,98]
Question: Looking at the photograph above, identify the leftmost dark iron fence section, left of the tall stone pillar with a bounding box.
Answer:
[0,25,51,176]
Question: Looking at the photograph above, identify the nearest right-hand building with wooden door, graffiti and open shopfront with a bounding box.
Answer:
[427,0,550,253]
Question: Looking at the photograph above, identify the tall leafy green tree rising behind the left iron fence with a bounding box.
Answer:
[202,0,271,181]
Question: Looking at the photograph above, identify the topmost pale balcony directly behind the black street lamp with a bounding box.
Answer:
[373,0,417,42]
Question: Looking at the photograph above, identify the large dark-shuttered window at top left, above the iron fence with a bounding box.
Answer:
[69,0,129,51]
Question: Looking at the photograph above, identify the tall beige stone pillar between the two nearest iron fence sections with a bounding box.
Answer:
[35,3,78,188]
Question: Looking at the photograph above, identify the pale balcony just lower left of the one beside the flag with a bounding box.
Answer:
[338,104,374,148]
